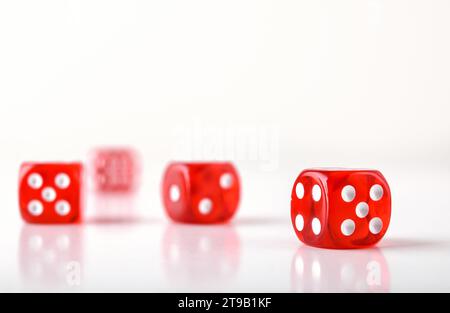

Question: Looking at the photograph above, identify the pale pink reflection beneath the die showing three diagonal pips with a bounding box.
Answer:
[162,224,240,290]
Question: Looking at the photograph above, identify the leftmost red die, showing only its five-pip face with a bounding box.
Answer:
[19,163,82,224]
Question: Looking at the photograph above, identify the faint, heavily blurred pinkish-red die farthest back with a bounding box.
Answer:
[92,148,139,192]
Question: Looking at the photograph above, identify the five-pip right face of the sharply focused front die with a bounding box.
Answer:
[328,171,391,248]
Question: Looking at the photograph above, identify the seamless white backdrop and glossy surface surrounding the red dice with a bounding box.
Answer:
[0,0,450,291]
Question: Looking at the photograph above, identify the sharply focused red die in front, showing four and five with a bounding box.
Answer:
[291,169,391,249]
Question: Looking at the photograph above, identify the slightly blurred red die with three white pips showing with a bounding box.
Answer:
[162,163,240,224]
